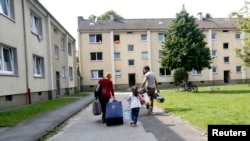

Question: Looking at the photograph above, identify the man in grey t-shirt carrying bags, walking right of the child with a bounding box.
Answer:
[141,66,159,114]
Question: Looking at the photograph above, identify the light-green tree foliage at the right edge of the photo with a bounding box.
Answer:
[229,1,250,67]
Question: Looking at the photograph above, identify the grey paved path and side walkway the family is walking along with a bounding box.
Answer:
[0,93,207,141]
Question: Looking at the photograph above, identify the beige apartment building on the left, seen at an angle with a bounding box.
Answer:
[0,0,78,110]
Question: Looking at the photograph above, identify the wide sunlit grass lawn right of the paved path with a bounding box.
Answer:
[156,84,250,131]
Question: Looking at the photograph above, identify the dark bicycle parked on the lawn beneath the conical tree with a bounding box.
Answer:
[175,81,198,92]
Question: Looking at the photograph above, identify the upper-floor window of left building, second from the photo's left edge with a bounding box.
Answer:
[30,13,43,41]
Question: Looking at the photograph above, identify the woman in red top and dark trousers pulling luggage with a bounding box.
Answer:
[98,72,115,123]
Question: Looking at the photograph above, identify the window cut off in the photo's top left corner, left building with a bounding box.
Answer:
[0,0,15,19]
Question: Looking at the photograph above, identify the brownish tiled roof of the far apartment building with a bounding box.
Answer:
[78,18,237,31]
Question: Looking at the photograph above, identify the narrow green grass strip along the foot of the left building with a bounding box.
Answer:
[0,98,77,127]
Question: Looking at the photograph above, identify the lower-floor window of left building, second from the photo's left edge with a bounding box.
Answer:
[33,55,44,77]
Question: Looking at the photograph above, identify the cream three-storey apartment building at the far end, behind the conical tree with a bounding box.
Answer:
[78,16,250,90]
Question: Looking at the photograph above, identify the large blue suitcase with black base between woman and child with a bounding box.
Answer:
[105,101,123,126]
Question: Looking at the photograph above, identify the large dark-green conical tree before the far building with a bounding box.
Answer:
[161,6,211,81]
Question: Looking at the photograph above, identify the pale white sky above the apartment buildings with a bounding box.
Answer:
[39,0,246,45]
